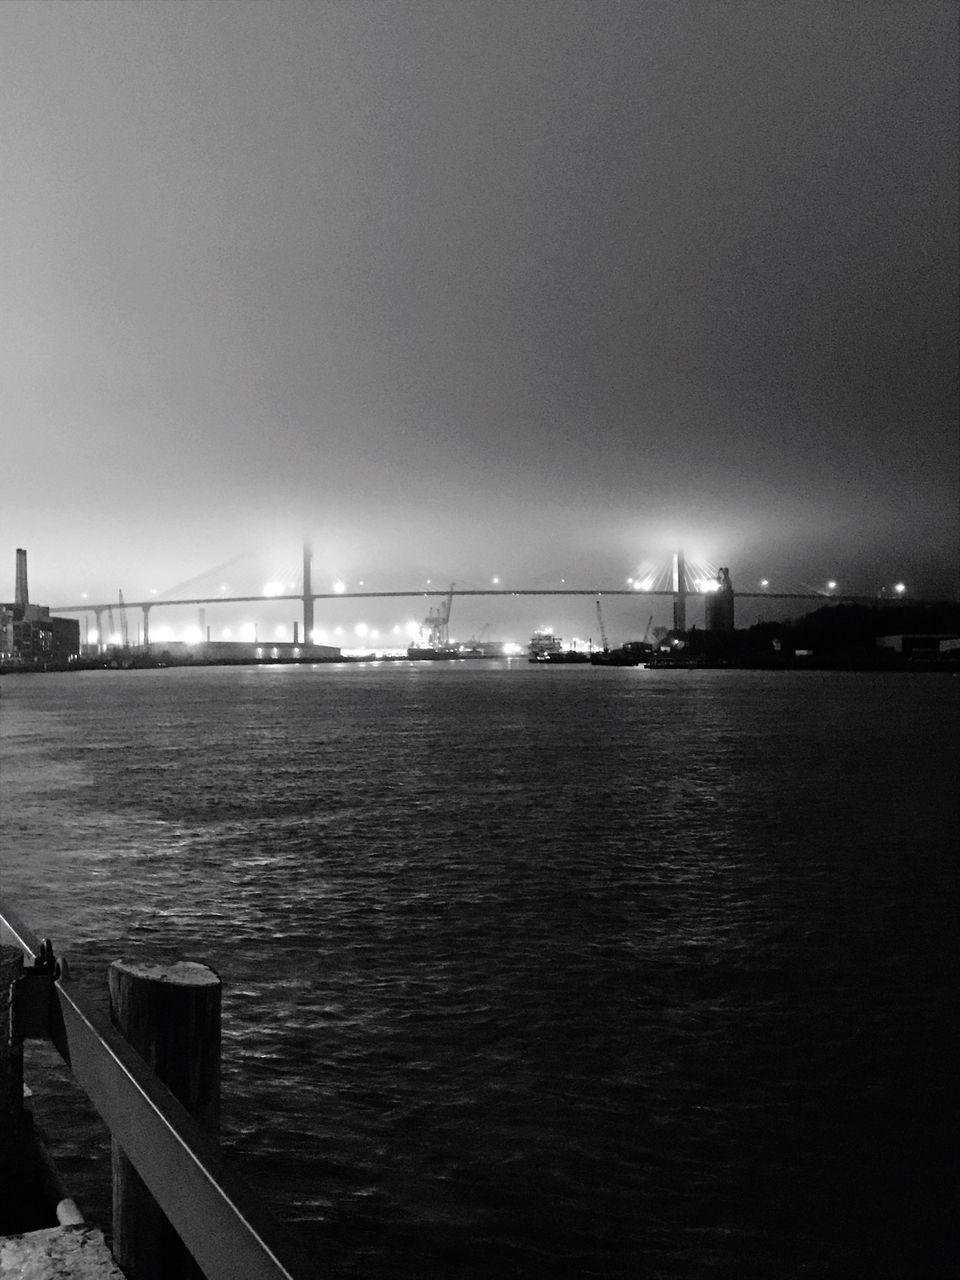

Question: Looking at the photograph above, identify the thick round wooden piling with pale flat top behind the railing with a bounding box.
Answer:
[109,960,220,1280]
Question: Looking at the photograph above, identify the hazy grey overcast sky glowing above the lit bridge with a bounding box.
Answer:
[0,0,959,603]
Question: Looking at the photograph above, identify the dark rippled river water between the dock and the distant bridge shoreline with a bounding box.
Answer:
[0,660,960,1280]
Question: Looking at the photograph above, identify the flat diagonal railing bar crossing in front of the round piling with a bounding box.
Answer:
[0,906,317,1280]
